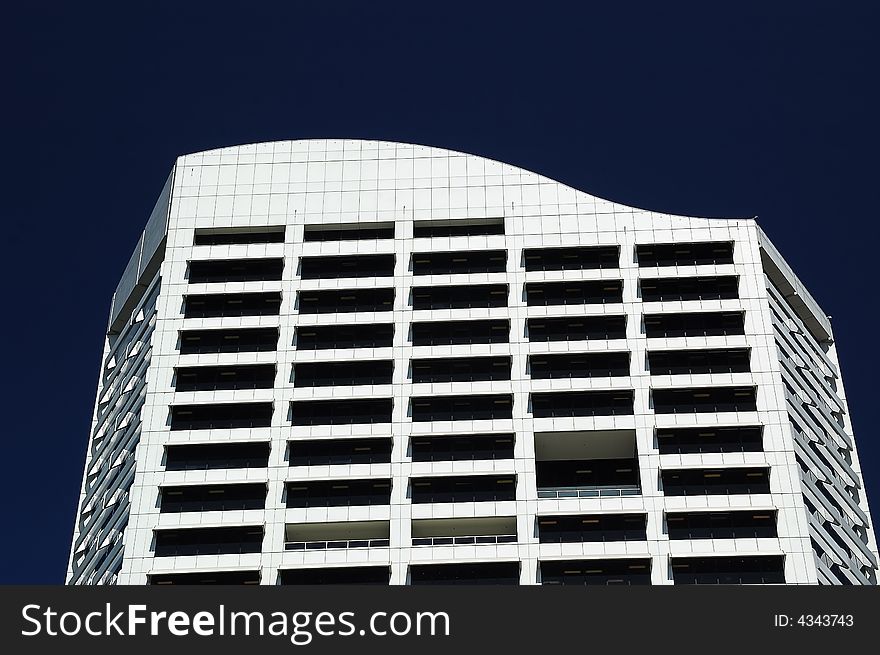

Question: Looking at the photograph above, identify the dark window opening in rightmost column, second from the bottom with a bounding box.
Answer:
[666,510,776,539]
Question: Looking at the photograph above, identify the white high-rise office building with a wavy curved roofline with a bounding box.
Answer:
[68,140,878,585]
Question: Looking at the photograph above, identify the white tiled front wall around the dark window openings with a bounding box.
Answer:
[103,141,872,584]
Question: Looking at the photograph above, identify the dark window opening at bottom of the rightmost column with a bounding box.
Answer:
[672,555,785,584]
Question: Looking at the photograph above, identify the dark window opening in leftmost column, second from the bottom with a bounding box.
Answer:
[154,525,263,557]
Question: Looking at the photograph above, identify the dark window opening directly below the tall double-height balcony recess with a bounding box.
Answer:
[538,514,648,544]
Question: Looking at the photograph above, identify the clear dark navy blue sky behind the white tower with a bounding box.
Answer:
[0,0,880,583]
